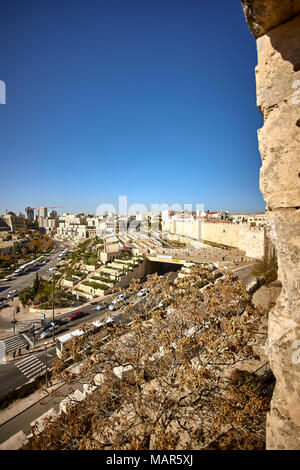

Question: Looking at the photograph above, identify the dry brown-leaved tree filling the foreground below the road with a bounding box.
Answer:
[27,266,271,450]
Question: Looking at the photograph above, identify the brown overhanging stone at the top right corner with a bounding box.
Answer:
[242,0,300,38]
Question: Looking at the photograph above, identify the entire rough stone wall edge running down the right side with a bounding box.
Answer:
[242,0,300,449]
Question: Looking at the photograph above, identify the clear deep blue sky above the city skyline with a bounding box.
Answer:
[0,0,265,213]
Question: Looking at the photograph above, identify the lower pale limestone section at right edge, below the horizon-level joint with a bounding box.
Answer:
[267,209,300,449]
